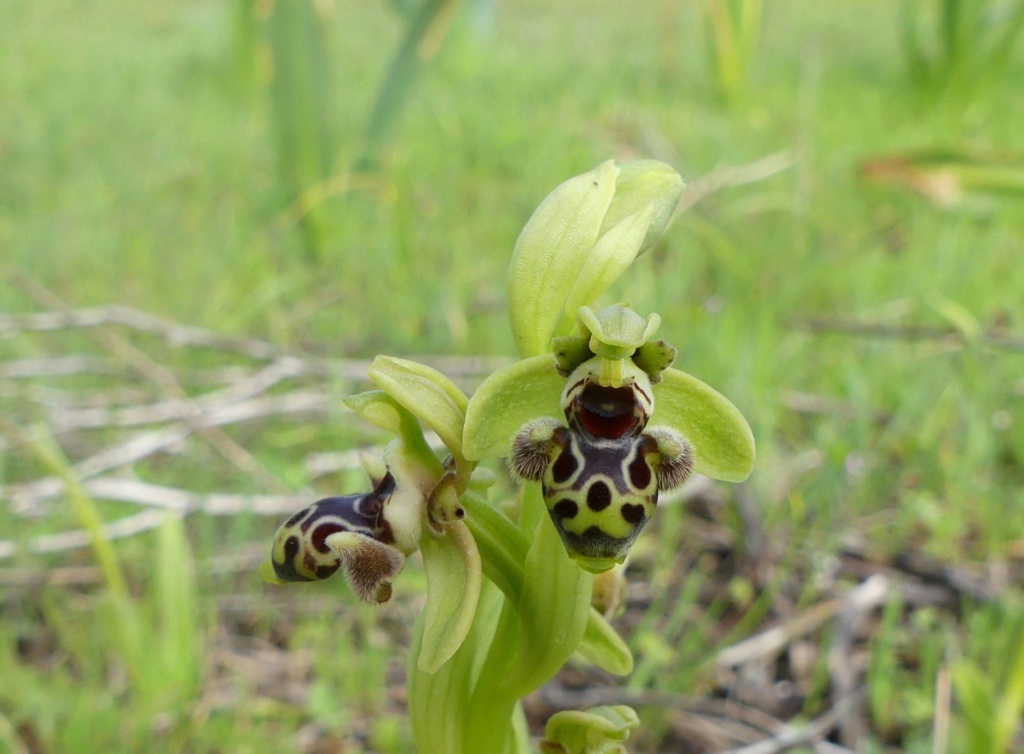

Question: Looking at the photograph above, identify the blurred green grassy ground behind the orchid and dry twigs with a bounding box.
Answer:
[0,0,1024,753]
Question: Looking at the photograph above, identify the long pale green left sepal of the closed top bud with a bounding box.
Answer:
[508,160,618,357]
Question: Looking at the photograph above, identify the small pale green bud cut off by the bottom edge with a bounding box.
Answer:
[541,705,640,754]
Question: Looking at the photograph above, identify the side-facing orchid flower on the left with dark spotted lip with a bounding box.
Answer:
[261,357,483,672]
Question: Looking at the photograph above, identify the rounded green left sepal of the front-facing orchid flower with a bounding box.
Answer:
[462,353,565,461]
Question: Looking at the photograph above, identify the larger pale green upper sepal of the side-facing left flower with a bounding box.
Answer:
[368,357,469,455]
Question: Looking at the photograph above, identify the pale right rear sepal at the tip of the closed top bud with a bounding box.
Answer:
[601,160,686,256]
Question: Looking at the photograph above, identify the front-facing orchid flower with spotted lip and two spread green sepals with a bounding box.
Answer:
[463,304,755,573]
